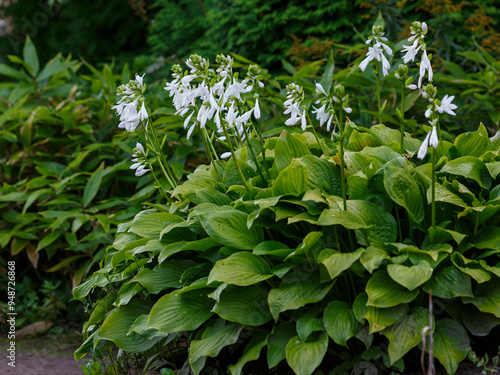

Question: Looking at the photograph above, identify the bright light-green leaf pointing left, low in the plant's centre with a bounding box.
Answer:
[208,251,273,286]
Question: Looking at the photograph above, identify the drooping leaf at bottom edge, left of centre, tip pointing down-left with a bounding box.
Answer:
[189,319,244,375]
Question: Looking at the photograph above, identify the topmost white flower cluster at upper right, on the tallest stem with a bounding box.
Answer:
[401,21,433,89]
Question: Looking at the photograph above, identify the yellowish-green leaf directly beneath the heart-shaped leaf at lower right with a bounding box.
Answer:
[366,270,418,308]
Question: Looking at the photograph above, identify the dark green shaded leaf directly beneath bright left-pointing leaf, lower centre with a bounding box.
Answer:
[212,286,272,326]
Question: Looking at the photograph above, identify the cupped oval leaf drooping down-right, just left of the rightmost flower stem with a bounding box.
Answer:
[384,167,424,223]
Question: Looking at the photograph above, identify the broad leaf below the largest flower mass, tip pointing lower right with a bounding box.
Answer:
[200,206,264,250]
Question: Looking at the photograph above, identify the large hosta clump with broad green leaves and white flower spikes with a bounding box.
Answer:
[74,25,500,375]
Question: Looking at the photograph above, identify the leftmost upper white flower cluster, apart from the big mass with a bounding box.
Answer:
[111,74,148,132]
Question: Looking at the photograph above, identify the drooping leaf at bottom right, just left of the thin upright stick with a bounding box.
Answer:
[382,307,429,366]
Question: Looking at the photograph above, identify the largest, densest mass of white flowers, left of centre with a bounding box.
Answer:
[165,55,263,139]
